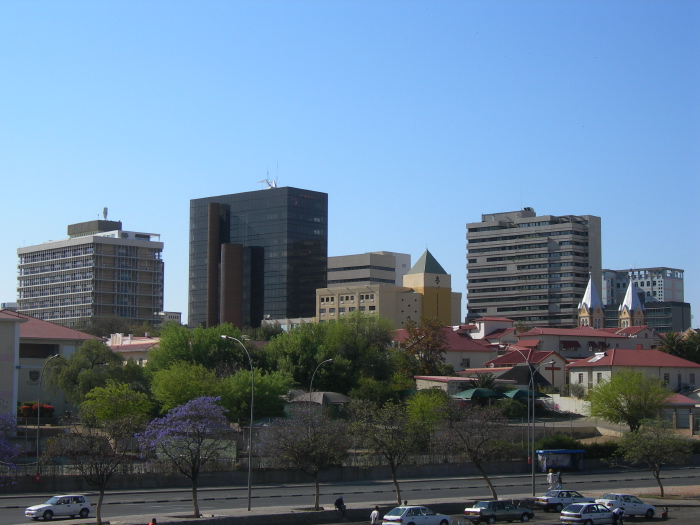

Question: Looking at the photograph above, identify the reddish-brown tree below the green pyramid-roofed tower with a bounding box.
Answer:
[399,317,447,376]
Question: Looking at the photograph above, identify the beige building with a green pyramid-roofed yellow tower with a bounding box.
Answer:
[316,250,462,328]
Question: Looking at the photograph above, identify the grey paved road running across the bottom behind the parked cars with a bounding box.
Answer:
[0,467,700,525]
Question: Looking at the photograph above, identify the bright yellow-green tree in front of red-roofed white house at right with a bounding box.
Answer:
[587,370,671,432]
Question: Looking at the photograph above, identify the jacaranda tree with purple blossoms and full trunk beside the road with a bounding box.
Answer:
[136,397,233,518]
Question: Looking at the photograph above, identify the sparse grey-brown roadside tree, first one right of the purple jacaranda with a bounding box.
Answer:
[260,406,350,510]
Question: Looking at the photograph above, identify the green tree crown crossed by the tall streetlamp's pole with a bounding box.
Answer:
[219,368,293,422]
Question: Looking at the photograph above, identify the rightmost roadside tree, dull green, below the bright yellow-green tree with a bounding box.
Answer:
[618,419,692,498]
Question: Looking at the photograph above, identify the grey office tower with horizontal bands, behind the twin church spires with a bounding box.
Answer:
[467,208,601,327]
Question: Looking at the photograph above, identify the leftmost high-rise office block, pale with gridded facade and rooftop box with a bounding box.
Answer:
[17,220,163,327]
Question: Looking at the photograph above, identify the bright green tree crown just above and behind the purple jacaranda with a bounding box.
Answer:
[151,361,219,413]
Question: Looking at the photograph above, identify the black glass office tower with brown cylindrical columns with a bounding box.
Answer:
[188,187,328,327]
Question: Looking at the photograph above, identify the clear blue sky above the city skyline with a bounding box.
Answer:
[0,0,700,327]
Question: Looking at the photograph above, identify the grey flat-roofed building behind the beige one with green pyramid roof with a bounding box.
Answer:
[328,252,411,288]
